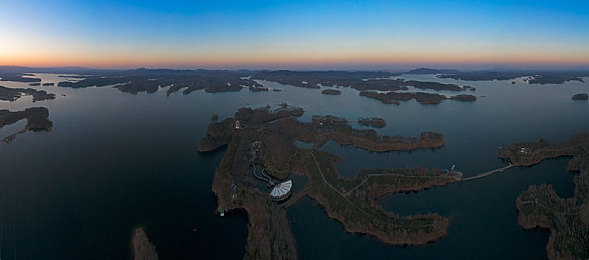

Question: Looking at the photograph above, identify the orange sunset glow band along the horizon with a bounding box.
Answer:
[0,47,589,68]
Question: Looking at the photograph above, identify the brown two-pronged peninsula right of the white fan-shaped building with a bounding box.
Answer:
[301,151,458,245]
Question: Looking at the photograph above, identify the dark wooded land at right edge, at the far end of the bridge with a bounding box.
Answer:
[498,132,589,259]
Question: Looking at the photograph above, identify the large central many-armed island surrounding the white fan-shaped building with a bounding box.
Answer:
[198,105,450,259]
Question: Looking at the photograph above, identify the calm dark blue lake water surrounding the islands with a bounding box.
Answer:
[0,74,589,259]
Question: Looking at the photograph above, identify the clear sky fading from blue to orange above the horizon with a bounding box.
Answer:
[0,0,589,69]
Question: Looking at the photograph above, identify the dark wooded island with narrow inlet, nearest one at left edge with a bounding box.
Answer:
[0,107,53,143]
